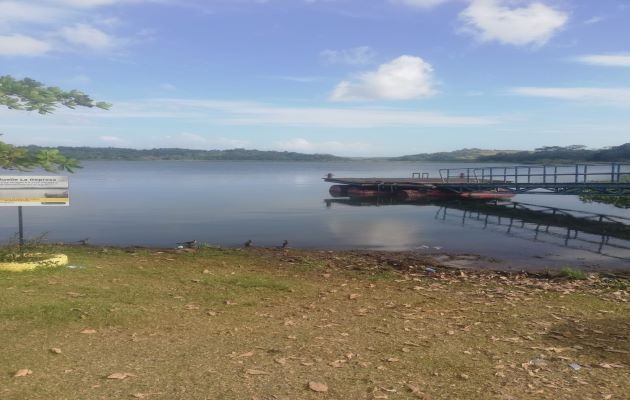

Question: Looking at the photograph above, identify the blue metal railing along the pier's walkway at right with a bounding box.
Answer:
[439,163,630,185]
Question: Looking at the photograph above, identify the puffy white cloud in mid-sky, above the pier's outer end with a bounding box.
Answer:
[330,56,435,101]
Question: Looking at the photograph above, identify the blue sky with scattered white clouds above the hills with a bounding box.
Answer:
[0,0,630,156]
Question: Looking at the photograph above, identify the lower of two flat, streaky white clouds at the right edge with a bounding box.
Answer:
[512,87,630,107]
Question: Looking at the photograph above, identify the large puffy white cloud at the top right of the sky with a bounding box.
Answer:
[460,0,569,46]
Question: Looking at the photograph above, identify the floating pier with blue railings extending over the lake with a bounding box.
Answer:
[324,163,630,196]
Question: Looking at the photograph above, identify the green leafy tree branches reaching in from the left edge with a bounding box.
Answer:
[0,75,111,172]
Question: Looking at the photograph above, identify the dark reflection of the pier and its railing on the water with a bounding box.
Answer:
[325,196,630,260]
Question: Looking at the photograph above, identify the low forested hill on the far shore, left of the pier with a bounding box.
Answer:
[29,146,345,161]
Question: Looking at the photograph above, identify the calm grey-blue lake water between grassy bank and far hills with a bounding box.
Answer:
[0,161,630,268]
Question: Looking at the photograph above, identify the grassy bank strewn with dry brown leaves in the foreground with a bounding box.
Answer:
[0,247,630,400]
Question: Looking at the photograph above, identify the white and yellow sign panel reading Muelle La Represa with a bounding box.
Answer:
[0,175,70,207]
